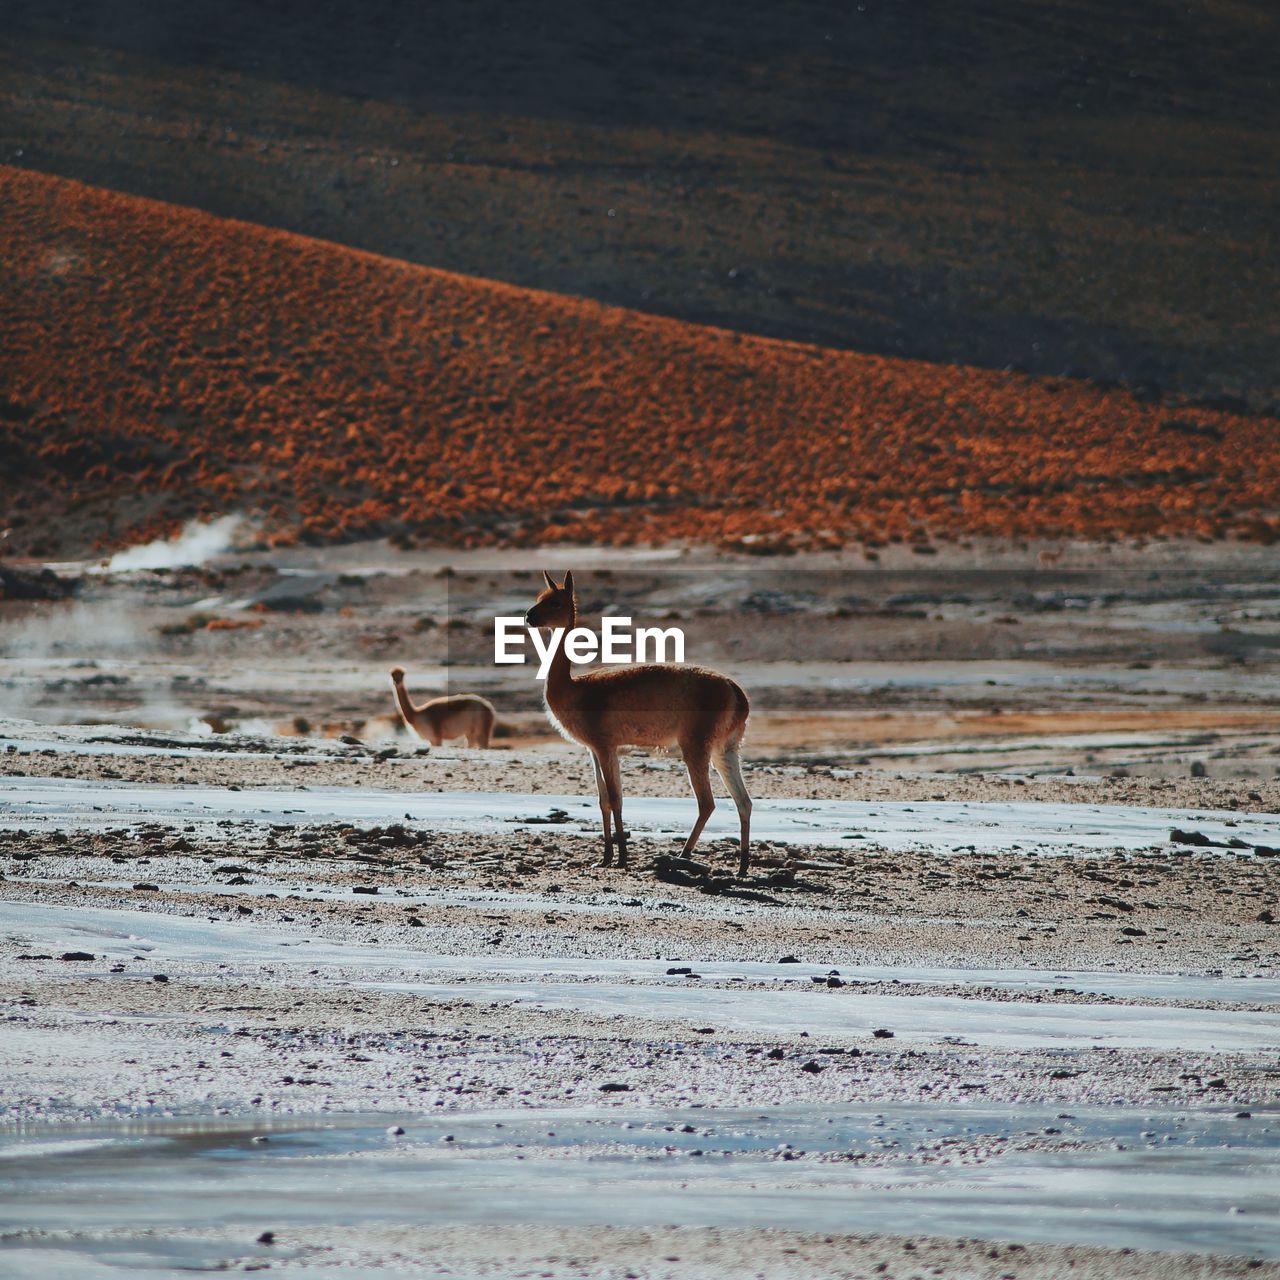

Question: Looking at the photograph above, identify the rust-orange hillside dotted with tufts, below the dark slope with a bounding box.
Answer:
[0,169,1280,554]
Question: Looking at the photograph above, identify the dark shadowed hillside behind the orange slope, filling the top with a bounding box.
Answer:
[0,0,1280,408]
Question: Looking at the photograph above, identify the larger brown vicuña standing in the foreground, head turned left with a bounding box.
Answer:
[525,571,751,876]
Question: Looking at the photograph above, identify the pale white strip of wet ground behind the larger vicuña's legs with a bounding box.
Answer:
[0,778,1280,855]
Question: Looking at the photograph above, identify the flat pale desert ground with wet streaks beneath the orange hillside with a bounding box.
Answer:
[0,544,1280,1280]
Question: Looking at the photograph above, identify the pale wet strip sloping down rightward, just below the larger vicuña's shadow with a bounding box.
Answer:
[0,904,1280,1052]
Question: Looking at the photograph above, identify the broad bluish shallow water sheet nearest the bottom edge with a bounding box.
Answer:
[0,1105,1280,1267]
